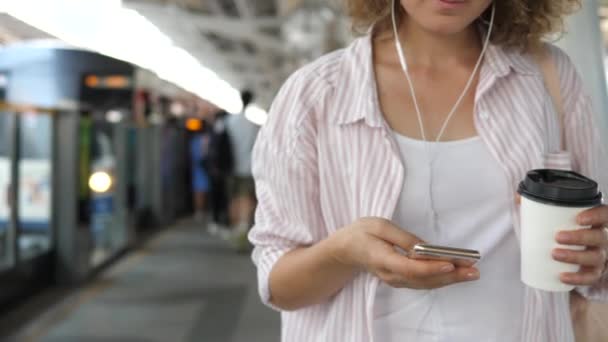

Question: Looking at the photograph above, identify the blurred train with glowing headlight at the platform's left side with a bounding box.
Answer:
[0,41,207,310]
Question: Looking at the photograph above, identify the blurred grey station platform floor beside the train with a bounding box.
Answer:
[10,221,280,342]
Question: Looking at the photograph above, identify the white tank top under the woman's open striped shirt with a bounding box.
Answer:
[374,134,524,342]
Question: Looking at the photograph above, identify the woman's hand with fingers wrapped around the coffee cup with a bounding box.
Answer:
[553,205,608,286]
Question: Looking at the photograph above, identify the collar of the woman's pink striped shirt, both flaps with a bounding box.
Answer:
[333,31,540,127]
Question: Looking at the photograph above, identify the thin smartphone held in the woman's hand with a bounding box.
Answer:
[407,244,481,267]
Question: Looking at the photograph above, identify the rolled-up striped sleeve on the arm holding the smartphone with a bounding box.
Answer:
[249,72,327,309]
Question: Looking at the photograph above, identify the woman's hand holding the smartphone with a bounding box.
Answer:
[332,218,479,289]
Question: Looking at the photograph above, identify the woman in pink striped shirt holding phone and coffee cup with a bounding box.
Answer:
[250,0,608,342]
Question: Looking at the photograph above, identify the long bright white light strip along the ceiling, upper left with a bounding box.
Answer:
[5,0,243,112]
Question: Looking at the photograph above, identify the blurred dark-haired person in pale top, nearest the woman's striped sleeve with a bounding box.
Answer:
[226,90,259,250]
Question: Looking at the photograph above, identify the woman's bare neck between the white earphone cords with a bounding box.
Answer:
[398,18,482,68]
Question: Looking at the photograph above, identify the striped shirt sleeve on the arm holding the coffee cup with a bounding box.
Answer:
[554,46,608,302]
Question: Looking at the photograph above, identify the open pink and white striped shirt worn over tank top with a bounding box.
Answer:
[250,35,608,342]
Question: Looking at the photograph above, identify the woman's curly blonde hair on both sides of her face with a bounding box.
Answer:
[344,0,581,50]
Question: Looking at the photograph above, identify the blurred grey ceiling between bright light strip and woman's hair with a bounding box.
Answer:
[123,0,350,106]
